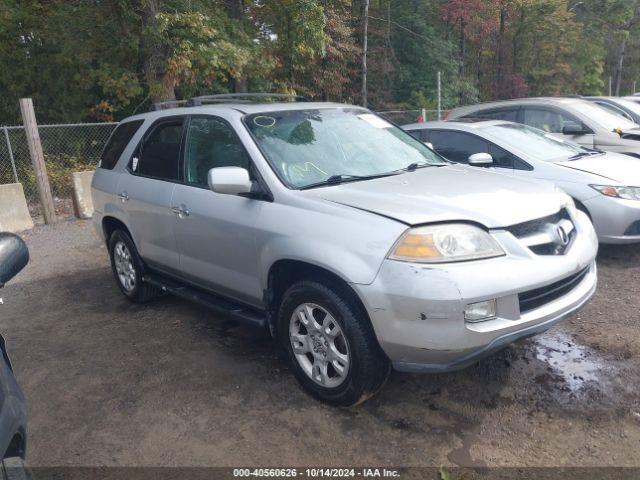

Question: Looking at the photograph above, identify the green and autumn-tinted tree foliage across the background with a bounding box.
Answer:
[0,0,640,124]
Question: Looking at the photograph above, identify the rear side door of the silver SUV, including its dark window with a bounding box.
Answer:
[118,116,185,273]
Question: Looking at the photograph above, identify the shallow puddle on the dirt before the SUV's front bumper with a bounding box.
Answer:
[534,332,604,391]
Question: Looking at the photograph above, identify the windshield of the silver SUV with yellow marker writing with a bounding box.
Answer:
[244,108,447,188]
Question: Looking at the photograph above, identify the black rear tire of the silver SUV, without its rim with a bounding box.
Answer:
[109,230,161,303]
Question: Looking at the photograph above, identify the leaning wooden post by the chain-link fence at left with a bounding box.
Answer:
[20,98,56,225]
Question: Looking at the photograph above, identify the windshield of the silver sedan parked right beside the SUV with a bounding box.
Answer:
[480,123,592,162]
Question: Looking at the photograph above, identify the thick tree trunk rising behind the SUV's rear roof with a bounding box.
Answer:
[142,0,176,102]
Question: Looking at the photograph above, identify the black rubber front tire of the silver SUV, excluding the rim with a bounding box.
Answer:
[278,281,390,407]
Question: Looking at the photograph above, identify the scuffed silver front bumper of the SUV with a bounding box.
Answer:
[353,214,597,372]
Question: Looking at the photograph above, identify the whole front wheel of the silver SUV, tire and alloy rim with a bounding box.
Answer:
[278,281,390,406]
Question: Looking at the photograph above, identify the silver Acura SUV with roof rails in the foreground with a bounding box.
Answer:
[93,97,597,405]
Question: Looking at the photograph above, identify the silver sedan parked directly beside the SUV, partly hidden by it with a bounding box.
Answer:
[403,120,640,243]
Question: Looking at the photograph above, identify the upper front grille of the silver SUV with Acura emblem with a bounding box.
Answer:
[507,208,576,255]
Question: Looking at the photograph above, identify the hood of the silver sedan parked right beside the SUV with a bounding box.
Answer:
[557,152,640,186]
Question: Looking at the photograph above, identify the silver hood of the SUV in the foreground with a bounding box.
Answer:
[309,165,567,228]
